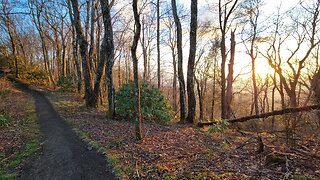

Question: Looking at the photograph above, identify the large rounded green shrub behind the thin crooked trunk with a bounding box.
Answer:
[116,81,173,122]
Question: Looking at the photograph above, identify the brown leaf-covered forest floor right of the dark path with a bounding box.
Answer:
[46,90,320,179]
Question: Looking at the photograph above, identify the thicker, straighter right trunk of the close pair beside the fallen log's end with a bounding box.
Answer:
[187,0,198,123]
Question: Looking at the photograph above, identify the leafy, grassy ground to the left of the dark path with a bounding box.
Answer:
[0,77,41,180]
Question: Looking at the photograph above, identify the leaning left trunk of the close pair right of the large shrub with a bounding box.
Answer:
[171,0,186,122]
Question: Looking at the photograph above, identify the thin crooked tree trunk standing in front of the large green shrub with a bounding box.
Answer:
[131,0,143,140]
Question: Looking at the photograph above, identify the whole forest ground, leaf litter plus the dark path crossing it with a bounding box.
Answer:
[0,77,320,179]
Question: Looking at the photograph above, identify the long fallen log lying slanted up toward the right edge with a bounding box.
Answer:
[228,104,320,123]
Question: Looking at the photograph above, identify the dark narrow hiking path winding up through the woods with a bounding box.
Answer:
[17,83,115,180]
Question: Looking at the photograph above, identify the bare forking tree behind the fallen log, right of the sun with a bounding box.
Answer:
[264,2,320,107]
